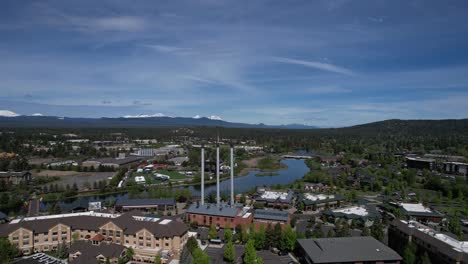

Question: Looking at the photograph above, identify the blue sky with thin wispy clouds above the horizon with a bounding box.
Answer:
[0,0,468,127]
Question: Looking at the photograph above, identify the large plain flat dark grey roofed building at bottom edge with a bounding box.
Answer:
[296,237,402,264]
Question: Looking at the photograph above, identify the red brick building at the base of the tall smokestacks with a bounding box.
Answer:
[185,203,253,228]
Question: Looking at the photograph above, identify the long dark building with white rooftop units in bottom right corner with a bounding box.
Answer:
[388,219,468,264]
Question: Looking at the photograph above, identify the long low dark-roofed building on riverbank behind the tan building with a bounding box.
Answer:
[115,198,177,214]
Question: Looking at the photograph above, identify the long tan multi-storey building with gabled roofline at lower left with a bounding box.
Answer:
[0,211,188,261]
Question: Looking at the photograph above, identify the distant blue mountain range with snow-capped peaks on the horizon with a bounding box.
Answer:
[0,114,318,129]
